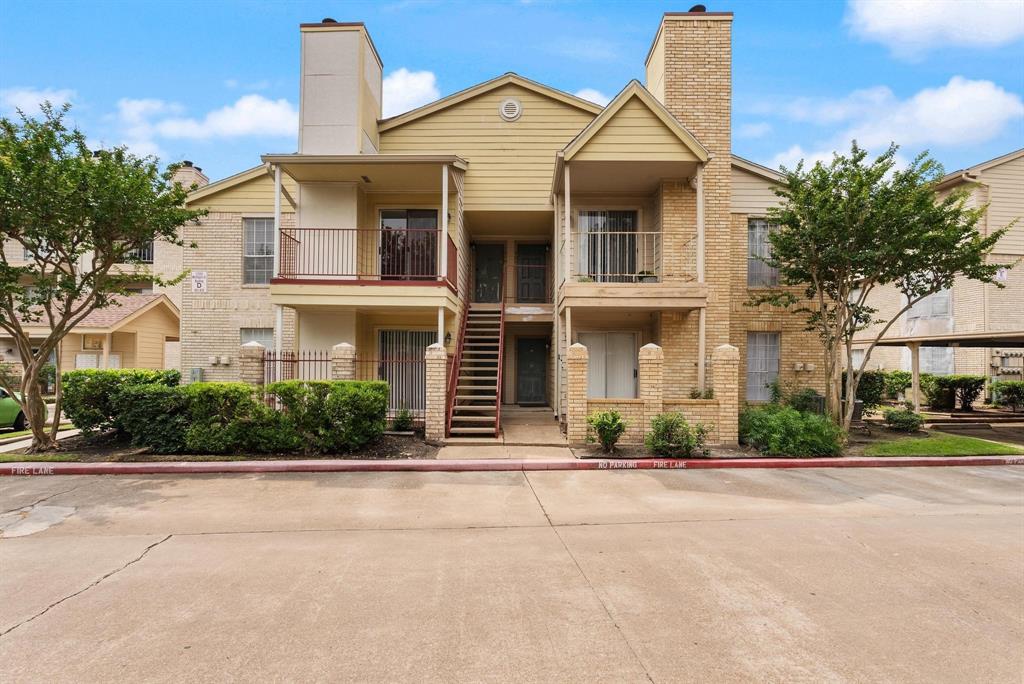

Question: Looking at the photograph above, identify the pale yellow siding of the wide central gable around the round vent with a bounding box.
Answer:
[381,84,593,211]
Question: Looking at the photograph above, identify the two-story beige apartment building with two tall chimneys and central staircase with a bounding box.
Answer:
[181,10,823,435]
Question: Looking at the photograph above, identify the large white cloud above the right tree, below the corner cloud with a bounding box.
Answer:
[773,76,1024,166]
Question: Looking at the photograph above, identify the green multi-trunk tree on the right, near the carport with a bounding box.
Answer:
[751,141,1009,430]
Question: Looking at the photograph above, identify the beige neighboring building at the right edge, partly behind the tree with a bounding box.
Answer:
[854,149,1024,389]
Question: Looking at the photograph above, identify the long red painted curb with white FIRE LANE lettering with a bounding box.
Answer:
[0,456,1024,476]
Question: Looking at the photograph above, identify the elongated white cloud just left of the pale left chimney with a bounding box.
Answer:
[155,95,299,140]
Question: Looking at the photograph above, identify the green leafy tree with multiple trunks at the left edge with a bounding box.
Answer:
[0,102,204,451]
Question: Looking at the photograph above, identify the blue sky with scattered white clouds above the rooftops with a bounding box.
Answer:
[0,0,1024,179]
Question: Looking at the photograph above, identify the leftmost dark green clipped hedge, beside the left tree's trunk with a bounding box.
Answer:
[61,369,181,435]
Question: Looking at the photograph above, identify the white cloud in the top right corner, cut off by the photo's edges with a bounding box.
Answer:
[846,0,1024,57]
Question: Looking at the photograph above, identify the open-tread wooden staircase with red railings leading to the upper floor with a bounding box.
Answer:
[447,304,505,437]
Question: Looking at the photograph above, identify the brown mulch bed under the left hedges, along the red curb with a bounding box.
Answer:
[14,434,437,463]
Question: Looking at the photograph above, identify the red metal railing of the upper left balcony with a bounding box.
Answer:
[278,228,459,288]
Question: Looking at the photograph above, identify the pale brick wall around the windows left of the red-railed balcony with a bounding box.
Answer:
[181,212,295,382]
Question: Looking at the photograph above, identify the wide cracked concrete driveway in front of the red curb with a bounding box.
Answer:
[0,466,1024,682]
